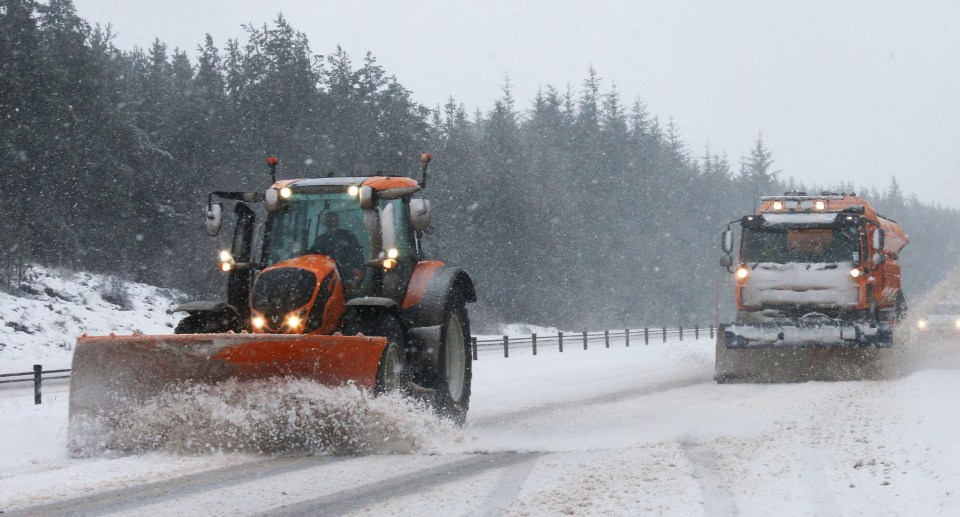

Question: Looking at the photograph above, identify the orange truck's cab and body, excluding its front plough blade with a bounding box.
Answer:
[721,192,907,343]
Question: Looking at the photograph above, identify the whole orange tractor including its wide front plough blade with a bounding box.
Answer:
[69,154,476,433]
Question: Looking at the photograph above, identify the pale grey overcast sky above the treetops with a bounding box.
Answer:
[75,0,960,208]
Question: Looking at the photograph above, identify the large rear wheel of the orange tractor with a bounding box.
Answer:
[433,300,473,425]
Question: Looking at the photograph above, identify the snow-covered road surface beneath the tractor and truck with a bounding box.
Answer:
[0,332,960,516]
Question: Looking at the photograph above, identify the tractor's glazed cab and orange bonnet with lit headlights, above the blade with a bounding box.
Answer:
[207,158,430,333]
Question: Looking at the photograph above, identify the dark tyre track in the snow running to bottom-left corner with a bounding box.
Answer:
[3,456,352,517]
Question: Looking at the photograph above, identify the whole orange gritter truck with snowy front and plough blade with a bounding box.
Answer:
[714,192,908,382]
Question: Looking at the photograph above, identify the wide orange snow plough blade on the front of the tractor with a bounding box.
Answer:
[64,333,387,431]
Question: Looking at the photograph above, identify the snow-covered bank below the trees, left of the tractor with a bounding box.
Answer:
[0,266,184,373]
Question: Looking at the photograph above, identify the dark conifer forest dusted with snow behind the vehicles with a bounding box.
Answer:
[0,0,960,328]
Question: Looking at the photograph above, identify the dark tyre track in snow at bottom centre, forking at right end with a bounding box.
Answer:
[255,452,542,517]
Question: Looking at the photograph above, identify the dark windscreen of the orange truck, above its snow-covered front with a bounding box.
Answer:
[740,226,860,264]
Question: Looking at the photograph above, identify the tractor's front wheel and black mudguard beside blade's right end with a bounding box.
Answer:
[343,309,406,394]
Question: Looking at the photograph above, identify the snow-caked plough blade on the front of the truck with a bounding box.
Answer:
[714,322,893,383]
